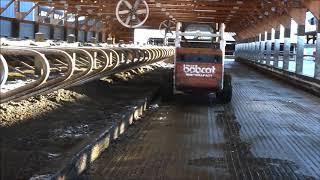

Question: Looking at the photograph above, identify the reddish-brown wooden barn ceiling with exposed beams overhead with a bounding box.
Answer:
[26,0,320,39]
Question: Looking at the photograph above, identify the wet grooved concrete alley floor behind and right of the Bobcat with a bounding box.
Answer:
[82,62,320,180]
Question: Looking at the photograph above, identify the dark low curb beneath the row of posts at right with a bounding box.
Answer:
[236,58,320,97]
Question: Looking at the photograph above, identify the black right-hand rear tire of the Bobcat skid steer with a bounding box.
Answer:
[217,74,232,103]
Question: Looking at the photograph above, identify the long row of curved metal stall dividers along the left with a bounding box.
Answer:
[0,46,175,103]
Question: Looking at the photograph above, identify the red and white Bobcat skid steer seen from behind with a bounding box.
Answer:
[173,23,232,103]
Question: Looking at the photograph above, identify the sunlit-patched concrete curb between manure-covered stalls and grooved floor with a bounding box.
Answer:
[49,92,156,180]
